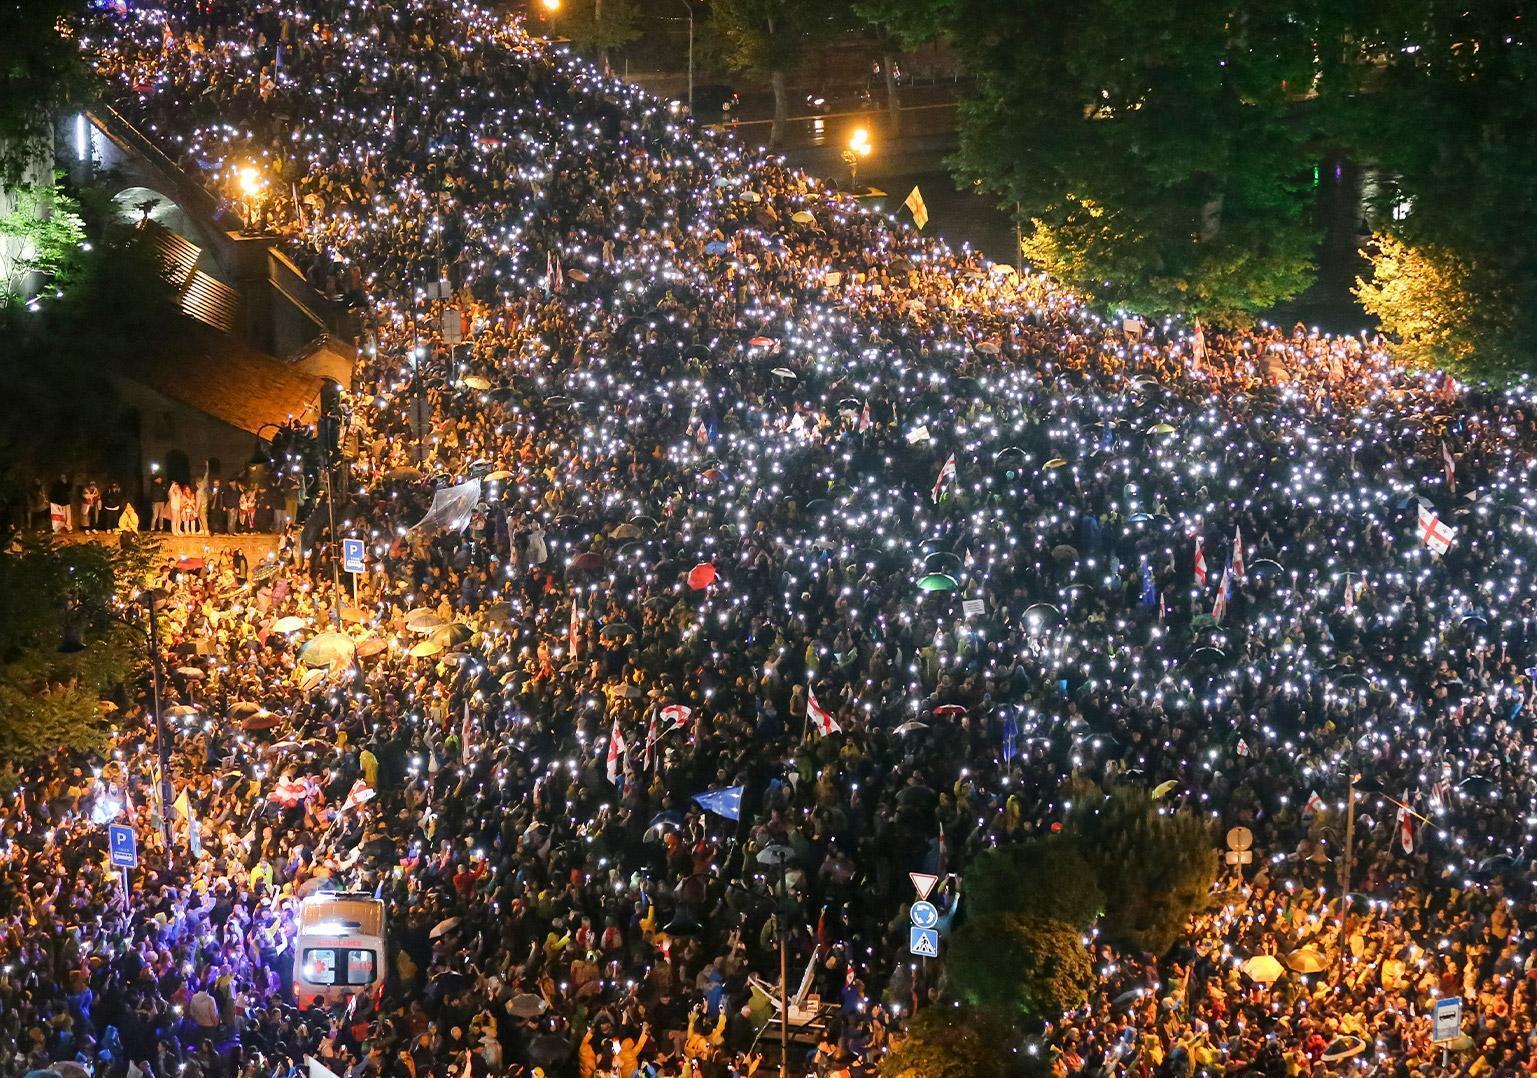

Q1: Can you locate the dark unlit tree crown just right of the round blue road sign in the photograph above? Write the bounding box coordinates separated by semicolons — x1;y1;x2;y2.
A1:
965;835;1105;930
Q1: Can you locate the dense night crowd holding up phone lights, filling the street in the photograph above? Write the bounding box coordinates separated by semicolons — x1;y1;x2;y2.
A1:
9;0;1537;1078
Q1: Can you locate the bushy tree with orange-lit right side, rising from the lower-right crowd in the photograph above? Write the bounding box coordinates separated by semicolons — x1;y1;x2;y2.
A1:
1064;781;1217;955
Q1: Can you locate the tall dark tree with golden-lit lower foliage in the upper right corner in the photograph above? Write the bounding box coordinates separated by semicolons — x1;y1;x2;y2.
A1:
1334;0;1537;377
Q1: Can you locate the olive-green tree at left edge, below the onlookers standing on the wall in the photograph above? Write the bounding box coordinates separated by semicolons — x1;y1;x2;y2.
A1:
0;538;149;761
